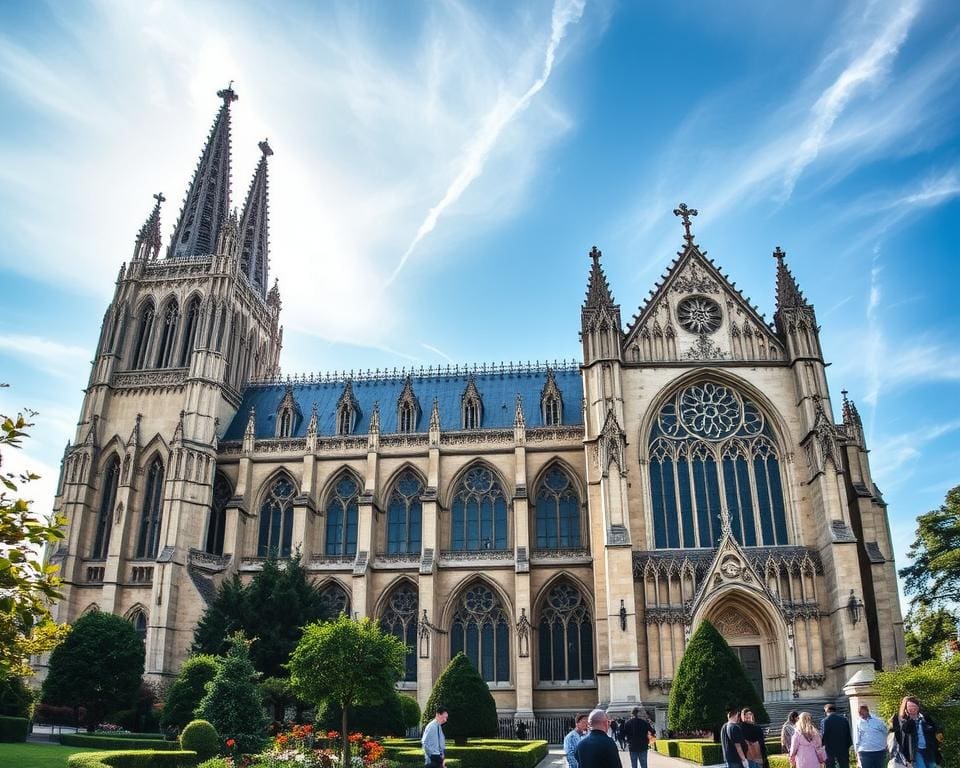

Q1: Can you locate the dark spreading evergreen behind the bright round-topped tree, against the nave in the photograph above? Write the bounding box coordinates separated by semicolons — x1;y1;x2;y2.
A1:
193;555;330;677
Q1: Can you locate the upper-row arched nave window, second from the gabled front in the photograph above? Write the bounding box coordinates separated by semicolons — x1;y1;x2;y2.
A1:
450;467;507;552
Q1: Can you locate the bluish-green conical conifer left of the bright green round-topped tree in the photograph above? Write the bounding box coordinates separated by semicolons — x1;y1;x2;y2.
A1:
197;635;267;753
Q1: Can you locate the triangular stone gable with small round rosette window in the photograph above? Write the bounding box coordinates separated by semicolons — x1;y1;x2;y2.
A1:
623;248;784;363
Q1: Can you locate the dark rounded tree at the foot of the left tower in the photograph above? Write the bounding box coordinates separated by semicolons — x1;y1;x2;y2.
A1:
42;611;144;730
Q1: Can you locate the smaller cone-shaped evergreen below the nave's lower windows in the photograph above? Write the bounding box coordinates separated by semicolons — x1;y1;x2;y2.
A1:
421;652;497;744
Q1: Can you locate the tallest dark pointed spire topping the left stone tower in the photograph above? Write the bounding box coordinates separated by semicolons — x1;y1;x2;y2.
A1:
168;81;237;258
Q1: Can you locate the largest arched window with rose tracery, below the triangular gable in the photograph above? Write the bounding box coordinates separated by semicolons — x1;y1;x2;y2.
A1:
648;381;788;548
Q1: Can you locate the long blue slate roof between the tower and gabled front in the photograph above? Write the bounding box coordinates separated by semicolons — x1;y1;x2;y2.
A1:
223;365;583;440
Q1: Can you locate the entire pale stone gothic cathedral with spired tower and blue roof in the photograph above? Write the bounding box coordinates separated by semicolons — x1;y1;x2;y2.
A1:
51;88;906;727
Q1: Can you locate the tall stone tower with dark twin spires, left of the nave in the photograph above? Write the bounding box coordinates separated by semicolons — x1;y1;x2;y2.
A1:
52;87;282;675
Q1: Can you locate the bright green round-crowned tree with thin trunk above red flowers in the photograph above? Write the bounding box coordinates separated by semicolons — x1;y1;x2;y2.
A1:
289;616;407;765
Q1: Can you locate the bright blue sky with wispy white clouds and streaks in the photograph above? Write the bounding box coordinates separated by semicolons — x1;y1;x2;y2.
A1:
0;0;960;612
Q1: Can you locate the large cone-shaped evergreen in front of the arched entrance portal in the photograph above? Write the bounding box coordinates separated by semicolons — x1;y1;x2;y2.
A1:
667;621;769;735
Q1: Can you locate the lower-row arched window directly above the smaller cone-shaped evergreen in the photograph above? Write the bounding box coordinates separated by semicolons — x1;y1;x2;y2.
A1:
450;584;510;683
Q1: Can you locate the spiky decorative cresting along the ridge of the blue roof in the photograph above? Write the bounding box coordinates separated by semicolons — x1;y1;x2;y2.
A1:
248;360;581;387
